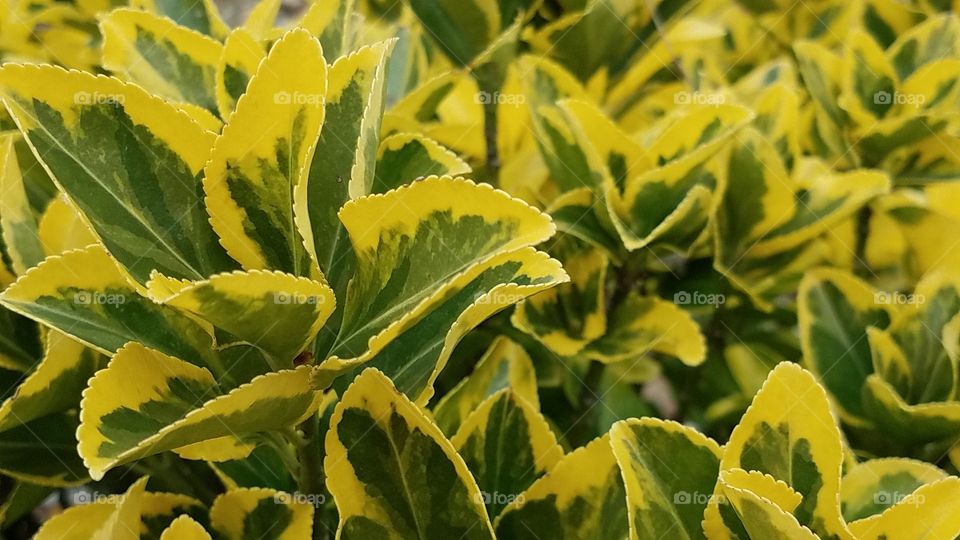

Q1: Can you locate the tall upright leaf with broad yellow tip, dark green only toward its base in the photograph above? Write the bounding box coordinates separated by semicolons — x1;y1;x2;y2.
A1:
203;30;326;276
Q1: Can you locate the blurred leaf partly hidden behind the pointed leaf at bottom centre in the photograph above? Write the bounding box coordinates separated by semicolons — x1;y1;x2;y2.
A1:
433;337;540;437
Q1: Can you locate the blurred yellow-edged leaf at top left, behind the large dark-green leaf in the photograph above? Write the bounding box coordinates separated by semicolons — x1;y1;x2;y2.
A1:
101;9;223;113
